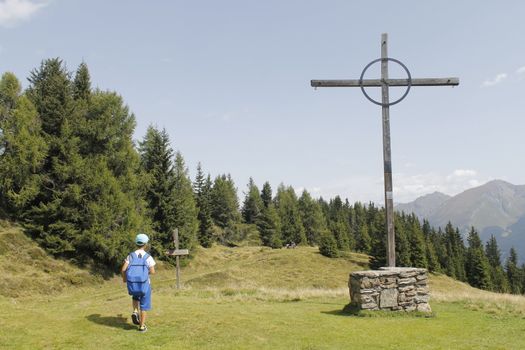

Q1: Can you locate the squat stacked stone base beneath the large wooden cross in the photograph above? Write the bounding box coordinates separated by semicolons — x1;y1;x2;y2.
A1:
348;267;432;313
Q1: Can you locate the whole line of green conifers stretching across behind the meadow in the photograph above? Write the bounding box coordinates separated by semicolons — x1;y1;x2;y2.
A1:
0;58;525;293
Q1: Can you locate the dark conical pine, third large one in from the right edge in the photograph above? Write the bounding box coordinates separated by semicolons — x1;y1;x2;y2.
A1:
466;227;493;290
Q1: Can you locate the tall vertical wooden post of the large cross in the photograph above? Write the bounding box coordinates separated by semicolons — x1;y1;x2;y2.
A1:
381;33;396;267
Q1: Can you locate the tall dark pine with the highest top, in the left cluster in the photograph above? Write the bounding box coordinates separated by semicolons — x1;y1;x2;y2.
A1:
26;59;85;256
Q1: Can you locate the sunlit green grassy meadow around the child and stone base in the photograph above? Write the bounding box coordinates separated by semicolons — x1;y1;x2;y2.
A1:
0;223;525;349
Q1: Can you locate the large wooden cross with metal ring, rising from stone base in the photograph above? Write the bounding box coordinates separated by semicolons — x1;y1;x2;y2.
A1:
310;33;459;267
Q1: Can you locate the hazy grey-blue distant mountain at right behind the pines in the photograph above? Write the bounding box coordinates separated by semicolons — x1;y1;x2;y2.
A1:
396;180;525;261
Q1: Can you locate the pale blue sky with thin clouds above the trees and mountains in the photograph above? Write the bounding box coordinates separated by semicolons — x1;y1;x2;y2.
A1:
0;0;525;203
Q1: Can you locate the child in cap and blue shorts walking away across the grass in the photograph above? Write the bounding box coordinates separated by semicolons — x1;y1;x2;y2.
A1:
121;233;156;332
